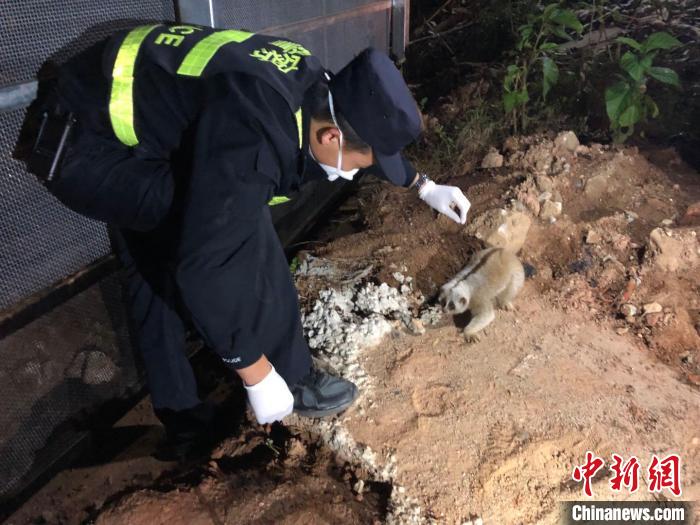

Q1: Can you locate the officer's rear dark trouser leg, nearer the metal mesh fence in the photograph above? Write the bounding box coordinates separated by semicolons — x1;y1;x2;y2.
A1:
113;230;200;413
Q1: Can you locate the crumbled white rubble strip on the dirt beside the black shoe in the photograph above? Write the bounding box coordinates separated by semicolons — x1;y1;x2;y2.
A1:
298;272;432;525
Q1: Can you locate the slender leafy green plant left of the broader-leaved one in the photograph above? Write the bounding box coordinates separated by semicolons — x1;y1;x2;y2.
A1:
503;3;583;133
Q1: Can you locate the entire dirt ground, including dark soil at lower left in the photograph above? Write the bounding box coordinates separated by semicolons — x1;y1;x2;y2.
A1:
9;129;700;525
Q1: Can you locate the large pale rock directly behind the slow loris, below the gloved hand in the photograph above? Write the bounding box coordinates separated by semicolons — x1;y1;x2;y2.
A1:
465;209;532;252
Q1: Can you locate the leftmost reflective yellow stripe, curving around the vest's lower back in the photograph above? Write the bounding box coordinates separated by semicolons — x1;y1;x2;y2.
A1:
109;25;158;146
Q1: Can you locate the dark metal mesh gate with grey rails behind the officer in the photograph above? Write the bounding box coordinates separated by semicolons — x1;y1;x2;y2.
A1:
0;0;408;517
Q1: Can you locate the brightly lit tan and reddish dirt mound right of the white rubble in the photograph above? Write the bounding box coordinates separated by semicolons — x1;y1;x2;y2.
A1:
302;137;700;525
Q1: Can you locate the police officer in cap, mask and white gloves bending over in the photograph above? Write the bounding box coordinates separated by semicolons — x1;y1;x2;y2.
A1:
41;25;469;456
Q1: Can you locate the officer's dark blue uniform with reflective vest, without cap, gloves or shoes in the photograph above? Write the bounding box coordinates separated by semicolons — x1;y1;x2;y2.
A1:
52;26;412;410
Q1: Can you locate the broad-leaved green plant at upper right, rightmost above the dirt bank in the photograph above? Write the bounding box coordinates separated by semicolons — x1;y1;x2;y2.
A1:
605;32;681;142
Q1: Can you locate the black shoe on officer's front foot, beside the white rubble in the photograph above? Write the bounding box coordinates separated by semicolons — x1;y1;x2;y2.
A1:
292;369;359;417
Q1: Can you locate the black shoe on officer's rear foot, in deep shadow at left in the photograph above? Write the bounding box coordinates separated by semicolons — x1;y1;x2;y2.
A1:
154;402;222;462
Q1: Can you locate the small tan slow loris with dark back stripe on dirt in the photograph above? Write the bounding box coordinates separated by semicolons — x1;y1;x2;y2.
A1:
439;248;525;342
